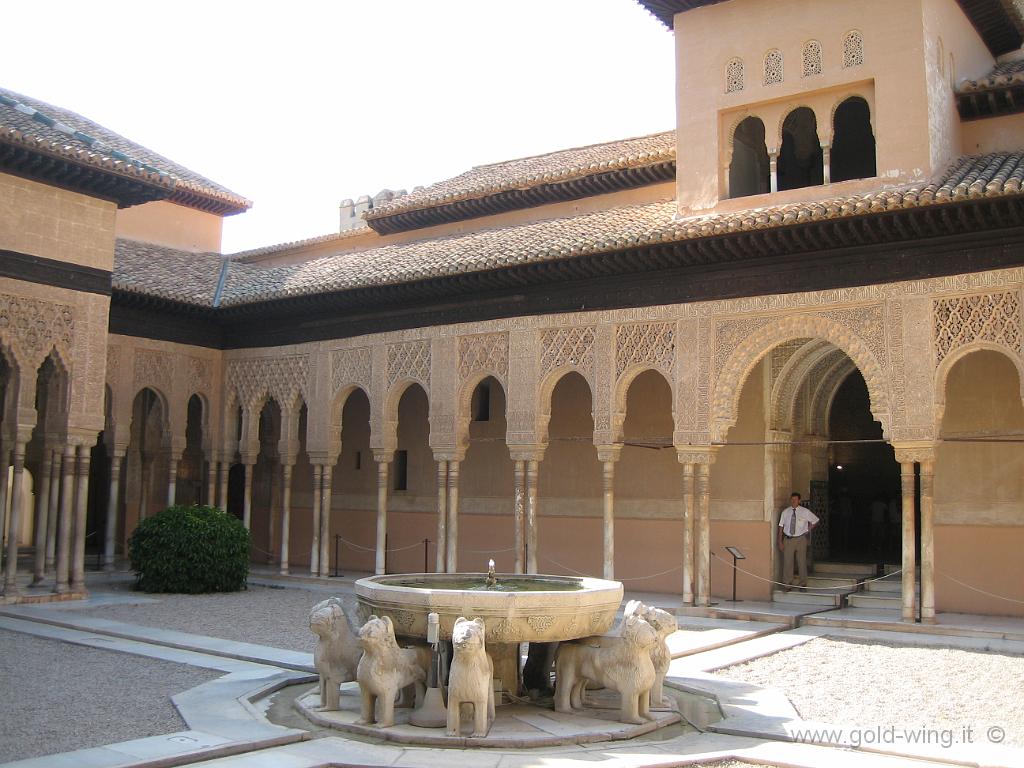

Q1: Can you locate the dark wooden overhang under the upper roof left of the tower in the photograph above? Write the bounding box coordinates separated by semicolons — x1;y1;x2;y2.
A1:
366;160;676;234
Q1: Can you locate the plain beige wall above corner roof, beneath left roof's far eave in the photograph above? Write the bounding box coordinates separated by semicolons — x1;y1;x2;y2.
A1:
116;201;223;253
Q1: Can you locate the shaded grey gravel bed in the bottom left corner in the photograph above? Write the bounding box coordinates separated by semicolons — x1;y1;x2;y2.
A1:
0;630;219;763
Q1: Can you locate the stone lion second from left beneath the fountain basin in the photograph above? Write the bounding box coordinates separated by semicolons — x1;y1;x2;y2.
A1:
355;615;430;728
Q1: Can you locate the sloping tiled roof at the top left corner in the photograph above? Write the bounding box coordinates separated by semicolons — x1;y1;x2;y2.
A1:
0;88;252;213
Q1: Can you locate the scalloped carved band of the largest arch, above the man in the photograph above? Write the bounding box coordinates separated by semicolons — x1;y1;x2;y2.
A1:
710;314;892;440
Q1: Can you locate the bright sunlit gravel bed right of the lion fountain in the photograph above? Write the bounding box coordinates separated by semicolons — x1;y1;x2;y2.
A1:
715;638;1024;746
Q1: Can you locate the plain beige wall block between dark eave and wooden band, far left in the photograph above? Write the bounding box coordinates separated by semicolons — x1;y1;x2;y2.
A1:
0;173;117;271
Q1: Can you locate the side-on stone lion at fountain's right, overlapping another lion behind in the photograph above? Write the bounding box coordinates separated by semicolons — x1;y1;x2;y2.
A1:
555;613;657;725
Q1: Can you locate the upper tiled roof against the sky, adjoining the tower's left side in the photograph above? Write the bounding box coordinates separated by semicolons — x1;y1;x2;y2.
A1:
366;131;676;221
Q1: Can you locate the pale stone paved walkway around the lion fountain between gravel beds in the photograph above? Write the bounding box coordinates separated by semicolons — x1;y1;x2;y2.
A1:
0;572;1024;768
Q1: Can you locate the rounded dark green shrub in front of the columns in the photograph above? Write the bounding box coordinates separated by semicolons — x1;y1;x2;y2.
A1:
128;506;249;594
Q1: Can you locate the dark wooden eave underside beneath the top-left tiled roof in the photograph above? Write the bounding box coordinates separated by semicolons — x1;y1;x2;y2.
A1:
0;135;172;208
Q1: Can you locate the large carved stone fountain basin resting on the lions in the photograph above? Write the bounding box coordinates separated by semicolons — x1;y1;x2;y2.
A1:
355;573;623;644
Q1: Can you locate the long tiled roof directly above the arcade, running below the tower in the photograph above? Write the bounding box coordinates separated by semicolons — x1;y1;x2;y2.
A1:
114;151;1024;307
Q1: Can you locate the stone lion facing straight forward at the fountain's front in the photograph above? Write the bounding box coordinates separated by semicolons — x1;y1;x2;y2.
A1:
447;616;495;738
